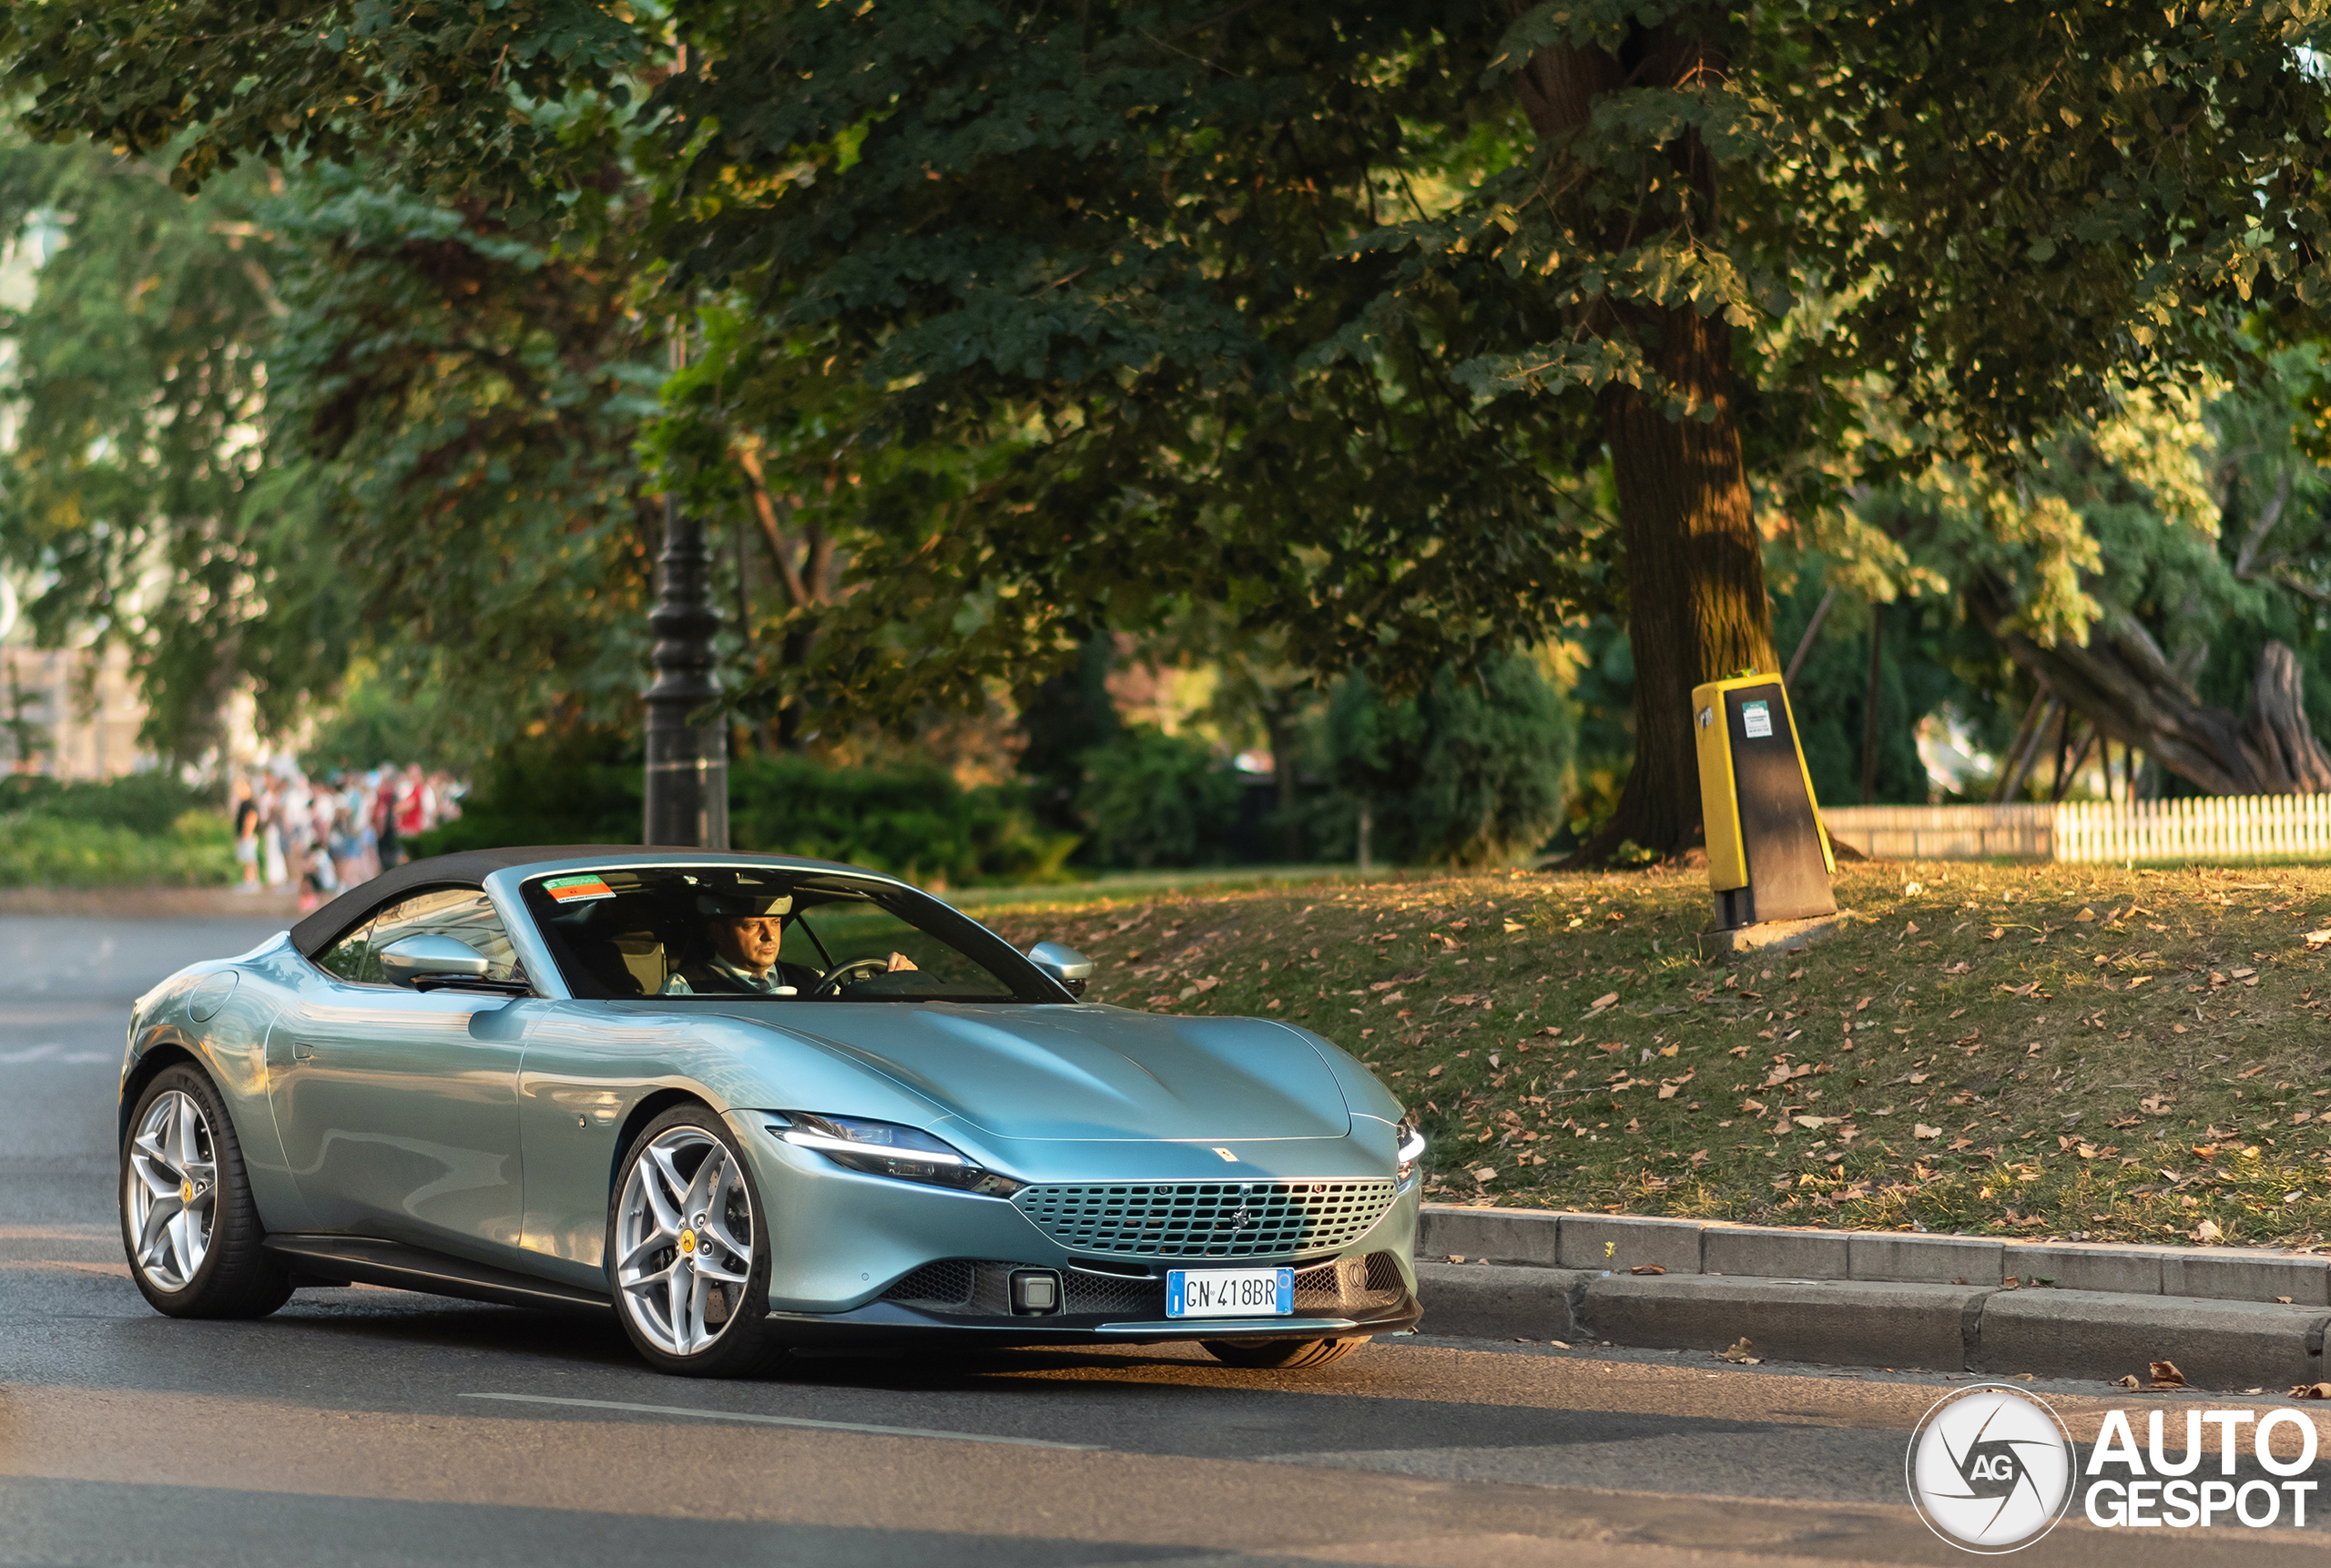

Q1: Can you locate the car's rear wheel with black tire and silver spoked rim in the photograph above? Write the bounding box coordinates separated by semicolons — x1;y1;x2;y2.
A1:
119;1063;291;1319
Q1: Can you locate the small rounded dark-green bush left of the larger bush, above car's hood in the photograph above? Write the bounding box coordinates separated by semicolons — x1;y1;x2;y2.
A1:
1077;725;1240;871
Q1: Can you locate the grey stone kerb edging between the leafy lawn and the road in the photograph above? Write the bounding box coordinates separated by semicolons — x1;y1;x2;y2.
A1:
1417;1205;2331;1393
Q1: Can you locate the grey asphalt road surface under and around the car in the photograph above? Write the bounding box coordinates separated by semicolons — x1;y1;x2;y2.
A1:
0;918;2331;1568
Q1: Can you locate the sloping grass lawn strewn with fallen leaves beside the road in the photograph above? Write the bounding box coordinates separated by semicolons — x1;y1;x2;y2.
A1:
969;862;2331;1247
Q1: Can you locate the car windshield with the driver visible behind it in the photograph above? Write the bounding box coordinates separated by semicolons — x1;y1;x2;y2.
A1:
524;867;1061;1002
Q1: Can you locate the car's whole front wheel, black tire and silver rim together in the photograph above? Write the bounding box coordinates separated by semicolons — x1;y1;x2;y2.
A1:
606;1105;781;1377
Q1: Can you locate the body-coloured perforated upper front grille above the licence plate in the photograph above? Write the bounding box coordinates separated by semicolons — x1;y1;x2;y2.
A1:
1012;1179;1394;1258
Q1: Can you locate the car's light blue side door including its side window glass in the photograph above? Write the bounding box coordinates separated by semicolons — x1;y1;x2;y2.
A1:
268;888;536;1260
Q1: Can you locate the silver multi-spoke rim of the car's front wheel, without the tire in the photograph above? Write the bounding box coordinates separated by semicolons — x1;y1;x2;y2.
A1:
616;1127;753;1356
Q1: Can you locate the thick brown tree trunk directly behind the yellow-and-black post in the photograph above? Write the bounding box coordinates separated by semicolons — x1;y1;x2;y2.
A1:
1515;18;1781;864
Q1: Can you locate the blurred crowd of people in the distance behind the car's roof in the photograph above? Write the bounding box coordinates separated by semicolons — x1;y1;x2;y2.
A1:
233;759;462;913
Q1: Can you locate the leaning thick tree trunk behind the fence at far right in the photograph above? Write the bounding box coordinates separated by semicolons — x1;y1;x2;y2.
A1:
1968;578;2331;795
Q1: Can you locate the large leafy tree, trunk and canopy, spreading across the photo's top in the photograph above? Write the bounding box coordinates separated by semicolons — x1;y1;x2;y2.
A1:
0;0;2331;850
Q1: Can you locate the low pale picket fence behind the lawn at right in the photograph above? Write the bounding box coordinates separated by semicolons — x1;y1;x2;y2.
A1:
1820;795;2331;862
